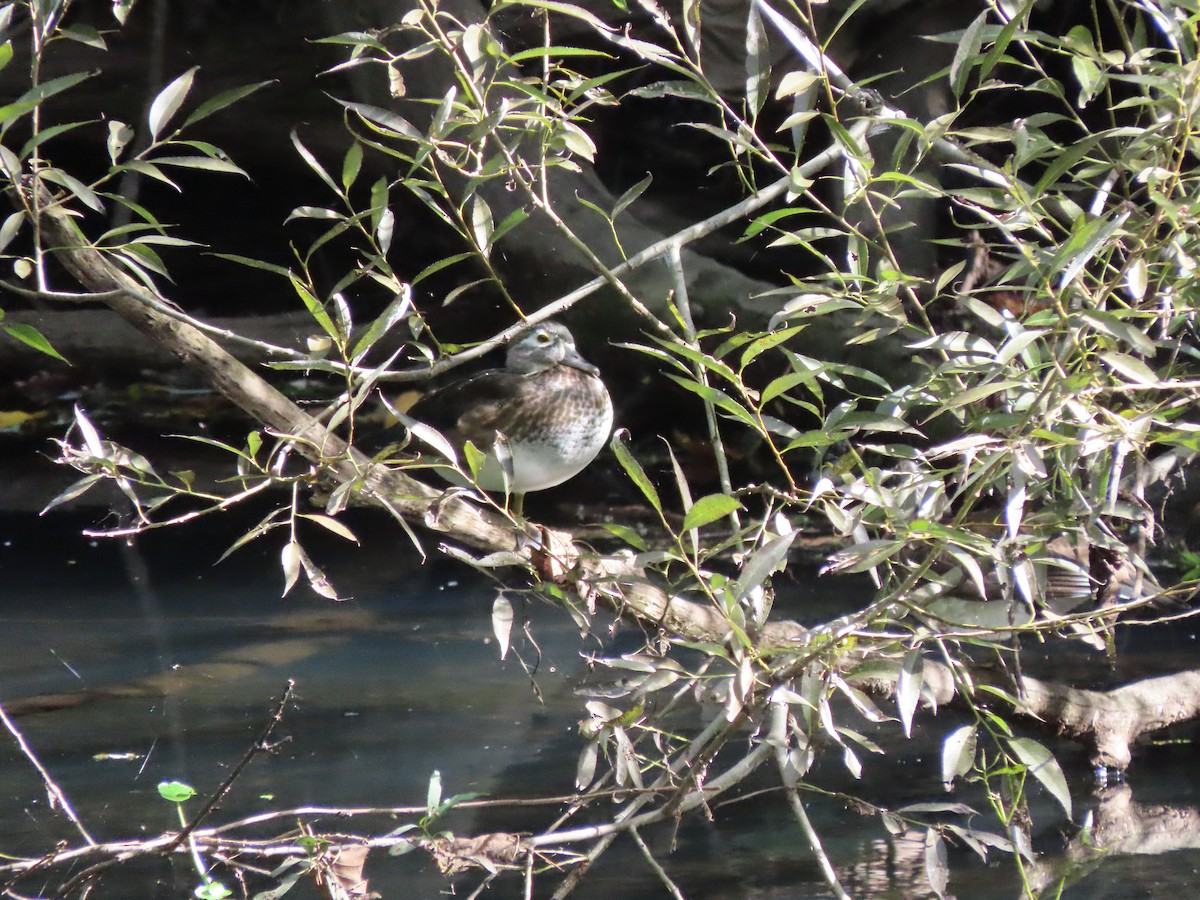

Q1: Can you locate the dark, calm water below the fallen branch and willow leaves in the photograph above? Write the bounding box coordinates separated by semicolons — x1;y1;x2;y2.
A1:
0;515;1200;899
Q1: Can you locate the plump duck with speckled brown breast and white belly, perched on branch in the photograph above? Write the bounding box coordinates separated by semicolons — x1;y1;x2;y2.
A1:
384;322;612;514
